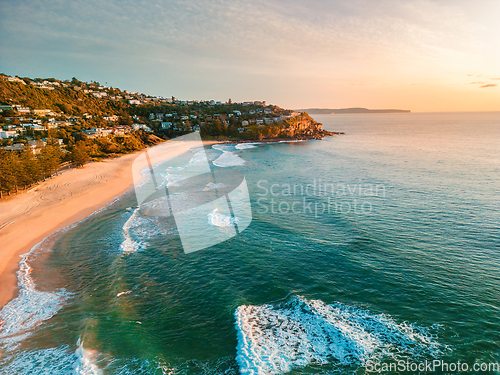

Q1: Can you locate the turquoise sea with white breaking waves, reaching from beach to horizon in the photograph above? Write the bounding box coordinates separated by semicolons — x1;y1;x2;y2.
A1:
0;113;500;374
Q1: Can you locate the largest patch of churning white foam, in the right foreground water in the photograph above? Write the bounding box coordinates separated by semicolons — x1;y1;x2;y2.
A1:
235;297;444;375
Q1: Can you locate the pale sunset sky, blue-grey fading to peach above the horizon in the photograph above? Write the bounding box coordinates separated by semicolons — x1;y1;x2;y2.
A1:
0;0;500;112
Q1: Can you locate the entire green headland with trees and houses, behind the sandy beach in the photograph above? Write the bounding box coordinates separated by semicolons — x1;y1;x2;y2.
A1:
0;74;333;196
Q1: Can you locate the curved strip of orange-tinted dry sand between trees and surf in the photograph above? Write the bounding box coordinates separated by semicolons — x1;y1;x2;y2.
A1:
0;141;200;308
